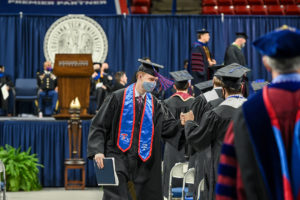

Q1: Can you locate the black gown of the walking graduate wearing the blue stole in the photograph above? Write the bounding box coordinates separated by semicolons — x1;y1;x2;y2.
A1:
87;89;184;200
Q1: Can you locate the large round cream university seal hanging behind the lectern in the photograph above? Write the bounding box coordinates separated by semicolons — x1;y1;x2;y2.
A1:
44;15;108;63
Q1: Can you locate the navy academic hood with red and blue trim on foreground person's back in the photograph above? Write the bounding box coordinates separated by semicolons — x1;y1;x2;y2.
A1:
243;81;300;200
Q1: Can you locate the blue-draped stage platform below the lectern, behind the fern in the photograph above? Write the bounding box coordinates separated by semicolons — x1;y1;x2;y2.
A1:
0;115;97;187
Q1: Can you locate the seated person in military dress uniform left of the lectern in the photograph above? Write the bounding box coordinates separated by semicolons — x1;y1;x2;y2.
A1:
37;61;58;117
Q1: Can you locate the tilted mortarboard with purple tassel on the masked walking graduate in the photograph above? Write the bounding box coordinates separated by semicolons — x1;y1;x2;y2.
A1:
138;59;173;90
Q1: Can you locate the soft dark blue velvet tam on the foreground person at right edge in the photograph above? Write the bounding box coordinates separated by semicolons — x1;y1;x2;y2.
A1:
253;25;300;58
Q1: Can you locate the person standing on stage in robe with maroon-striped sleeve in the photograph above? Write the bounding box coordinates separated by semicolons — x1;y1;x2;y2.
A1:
190;29;216;95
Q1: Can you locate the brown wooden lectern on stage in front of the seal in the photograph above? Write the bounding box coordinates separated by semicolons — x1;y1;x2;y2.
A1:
53;54;94;119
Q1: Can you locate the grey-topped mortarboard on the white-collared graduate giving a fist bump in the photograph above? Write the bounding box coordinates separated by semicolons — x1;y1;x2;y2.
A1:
215;63;251;89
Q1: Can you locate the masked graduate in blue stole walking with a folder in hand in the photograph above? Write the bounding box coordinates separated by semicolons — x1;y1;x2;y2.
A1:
87;59;184;200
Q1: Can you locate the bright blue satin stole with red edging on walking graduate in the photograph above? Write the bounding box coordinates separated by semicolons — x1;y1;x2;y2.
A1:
117;84;154;162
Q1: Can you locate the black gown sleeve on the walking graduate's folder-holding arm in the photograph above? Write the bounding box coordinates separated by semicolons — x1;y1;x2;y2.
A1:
87;94;118;159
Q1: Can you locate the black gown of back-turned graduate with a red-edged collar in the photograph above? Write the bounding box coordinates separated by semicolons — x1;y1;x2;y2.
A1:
163;95;194;197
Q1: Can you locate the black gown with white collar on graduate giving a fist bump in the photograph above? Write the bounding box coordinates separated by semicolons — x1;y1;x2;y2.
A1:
185;98;245;199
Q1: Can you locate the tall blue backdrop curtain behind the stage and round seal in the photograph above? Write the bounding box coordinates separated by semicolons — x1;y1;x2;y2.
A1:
0;14;300;84
